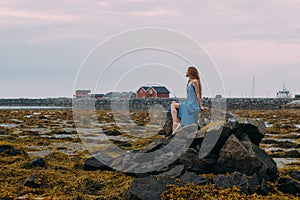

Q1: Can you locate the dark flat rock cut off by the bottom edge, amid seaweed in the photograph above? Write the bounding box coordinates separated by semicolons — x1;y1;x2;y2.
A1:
125;176;175;200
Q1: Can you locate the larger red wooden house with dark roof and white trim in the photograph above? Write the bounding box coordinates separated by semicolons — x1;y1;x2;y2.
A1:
136;86;170;99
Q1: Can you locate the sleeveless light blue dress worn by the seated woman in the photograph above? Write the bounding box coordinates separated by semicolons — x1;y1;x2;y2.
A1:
178;83;201;126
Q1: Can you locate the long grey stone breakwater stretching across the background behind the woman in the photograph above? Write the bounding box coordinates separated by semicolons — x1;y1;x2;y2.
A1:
0;98;295;110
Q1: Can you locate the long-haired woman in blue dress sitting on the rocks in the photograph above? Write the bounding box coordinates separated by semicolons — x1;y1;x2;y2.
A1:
171;67;208;134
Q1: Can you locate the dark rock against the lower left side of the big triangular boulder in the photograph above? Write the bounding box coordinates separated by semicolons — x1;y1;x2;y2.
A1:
179;148;212;174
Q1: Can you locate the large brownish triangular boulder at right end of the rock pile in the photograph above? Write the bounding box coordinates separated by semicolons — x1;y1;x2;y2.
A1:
213;135;278;181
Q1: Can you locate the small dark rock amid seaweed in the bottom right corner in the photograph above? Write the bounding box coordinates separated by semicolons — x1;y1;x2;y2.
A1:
278;177;300;195
